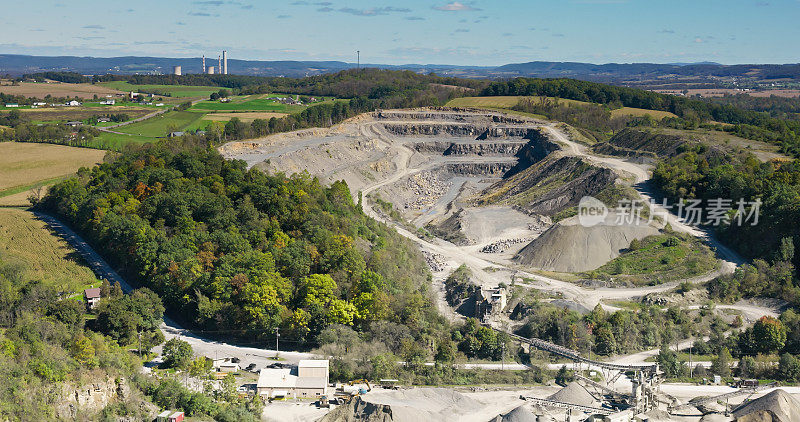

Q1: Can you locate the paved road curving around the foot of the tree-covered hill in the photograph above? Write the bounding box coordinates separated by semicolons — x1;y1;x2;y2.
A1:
34;212;315;369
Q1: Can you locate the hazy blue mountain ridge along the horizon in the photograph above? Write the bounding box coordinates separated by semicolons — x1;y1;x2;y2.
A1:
0;54;800;83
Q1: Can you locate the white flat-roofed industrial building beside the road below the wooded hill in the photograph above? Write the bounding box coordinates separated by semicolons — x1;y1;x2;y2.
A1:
256;360;330;398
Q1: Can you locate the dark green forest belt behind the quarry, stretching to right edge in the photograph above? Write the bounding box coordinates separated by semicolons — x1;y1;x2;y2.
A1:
481;78;800;156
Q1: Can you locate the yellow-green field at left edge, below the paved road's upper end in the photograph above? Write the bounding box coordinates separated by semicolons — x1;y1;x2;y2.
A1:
0;208;98;291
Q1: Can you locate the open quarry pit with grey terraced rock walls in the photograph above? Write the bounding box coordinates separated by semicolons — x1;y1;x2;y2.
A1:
220;109;664;271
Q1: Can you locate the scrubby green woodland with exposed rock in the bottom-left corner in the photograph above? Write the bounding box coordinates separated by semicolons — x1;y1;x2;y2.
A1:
0;251;260;422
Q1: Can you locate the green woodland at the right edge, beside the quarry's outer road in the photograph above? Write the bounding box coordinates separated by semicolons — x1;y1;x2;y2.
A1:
653;146;800;305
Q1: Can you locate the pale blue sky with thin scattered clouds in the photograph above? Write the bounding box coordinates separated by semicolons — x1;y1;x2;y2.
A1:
0;0;800;65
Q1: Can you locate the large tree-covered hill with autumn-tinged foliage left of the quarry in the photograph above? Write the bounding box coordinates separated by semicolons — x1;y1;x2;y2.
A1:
39;140;440;343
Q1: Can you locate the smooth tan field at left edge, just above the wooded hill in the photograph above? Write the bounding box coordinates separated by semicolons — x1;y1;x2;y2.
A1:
0;142;106;197
